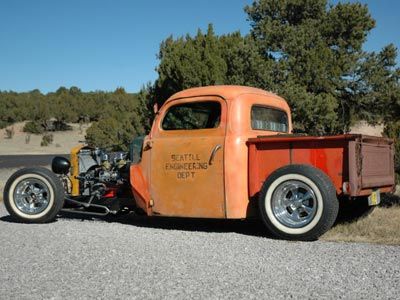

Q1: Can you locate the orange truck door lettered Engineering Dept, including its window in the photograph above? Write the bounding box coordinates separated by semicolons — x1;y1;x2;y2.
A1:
150;97;226;218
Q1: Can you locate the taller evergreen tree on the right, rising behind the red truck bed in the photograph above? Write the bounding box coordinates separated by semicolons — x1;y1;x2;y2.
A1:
245;0;399;134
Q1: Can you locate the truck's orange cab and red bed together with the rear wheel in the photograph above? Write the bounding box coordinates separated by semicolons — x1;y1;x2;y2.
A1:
130;86;394;239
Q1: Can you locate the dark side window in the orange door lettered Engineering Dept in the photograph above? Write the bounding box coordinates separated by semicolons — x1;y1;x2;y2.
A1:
162;101;221;130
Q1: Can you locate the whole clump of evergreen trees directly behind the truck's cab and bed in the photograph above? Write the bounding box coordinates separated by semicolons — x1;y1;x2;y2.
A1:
142;0;399;135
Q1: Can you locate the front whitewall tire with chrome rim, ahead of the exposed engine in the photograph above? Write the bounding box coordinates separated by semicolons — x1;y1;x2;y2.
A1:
3;168;64;223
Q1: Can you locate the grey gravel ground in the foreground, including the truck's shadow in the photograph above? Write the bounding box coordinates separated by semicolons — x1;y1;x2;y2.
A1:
0;203;400;299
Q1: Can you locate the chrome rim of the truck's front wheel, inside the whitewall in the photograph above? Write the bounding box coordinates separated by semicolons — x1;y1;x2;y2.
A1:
13;178;50;215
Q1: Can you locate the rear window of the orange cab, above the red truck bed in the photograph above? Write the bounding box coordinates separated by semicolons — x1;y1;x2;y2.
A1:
251;105;288;132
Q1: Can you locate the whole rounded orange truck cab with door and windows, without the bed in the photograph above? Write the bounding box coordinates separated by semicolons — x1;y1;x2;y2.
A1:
130;86;292;219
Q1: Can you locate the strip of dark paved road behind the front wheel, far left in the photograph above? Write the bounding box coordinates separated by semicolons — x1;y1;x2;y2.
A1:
0;154;69;169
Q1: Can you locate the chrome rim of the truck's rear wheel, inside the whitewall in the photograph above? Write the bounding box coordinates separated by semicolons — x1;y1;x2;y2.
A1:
271;180;317;228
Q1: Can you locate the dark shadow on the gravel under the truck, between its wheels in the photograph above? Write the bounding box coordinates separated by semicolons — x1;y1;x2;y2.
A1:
59;212;273;238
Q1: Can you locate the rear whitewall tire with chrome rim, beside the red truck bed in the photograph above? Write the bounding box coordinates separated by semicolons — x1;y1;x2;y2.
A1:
259;165;339;241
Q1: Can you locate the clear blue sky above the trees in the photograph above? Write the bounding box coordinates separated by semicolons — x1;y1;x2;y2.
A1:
0;0;400;93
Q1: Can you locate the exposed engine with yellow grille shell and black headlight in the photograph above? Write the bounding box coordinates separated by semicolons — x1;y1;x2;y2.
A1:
51;137;143;216
